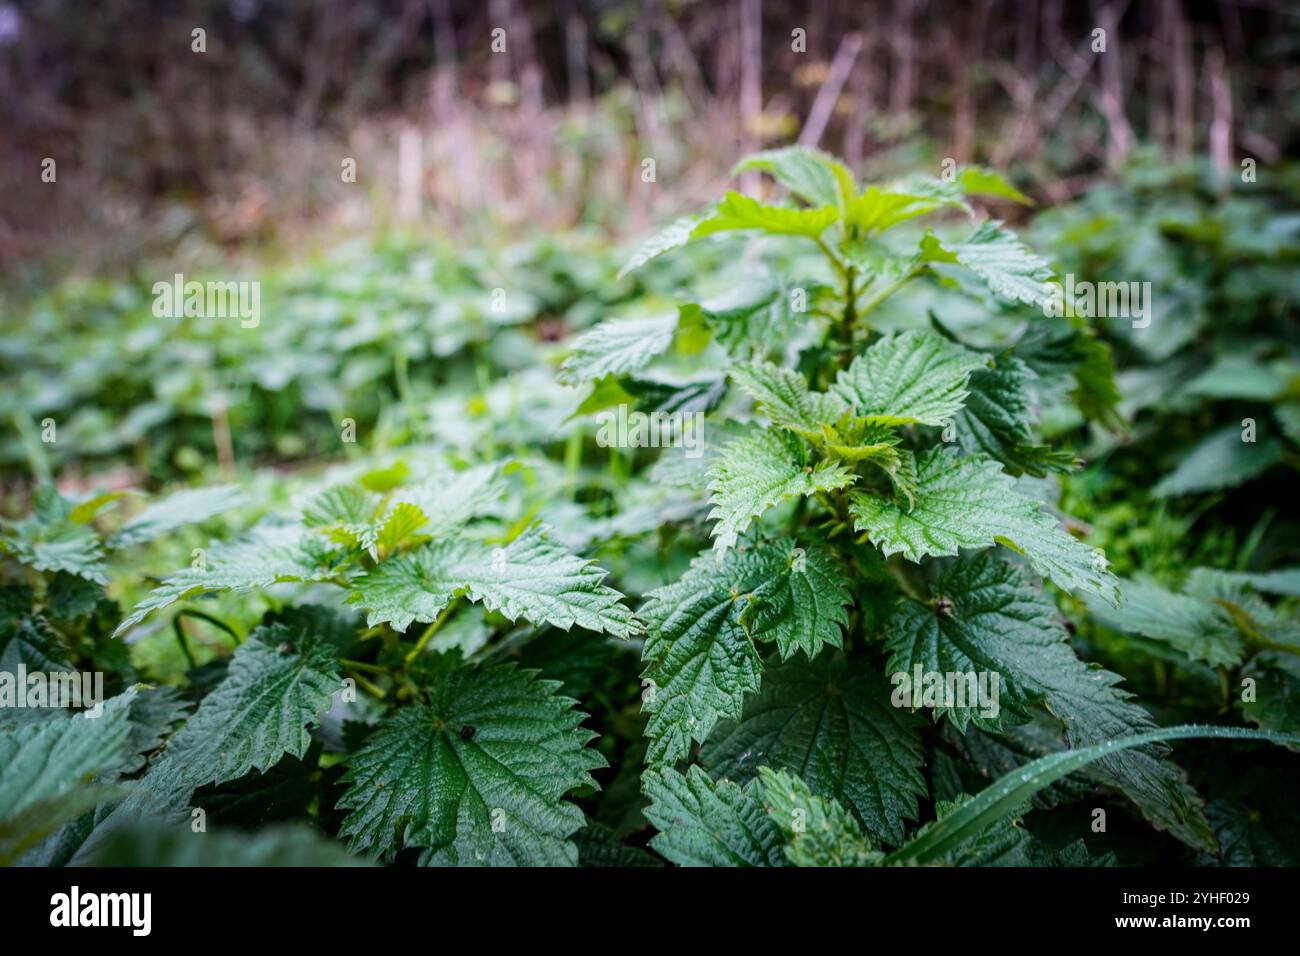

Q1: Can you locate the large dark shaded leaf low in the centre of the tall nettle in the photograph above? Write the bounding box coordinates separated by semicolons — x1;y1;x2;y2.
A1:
702;654;926;843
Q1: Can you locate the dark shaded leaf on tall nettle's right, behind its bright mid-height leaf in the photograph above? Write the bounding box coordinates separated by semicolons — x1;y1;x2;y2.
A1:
953;355;1078;477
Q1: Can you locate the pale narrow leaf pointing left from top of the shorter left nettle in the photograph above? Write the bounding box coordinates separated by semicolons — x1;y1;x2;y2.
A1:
113;524;343;637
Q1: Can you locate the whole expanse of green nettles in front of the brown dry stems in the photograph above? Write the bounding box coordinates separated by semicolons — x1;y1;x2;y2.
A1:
0;150;1300;865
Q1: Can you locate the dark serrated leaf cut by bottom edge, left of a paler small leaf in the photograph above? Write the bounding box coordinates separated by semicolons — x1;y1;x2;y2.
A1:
642;766;785;866
